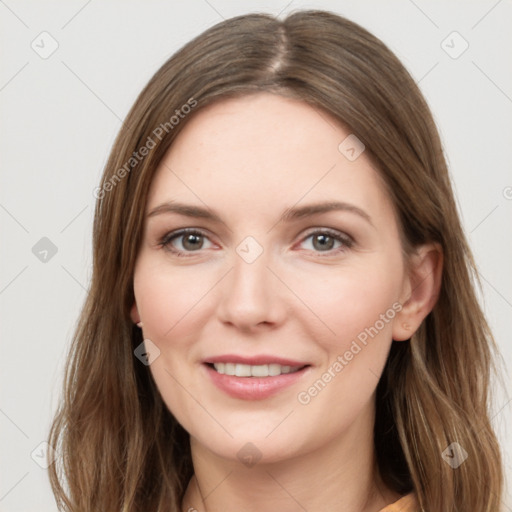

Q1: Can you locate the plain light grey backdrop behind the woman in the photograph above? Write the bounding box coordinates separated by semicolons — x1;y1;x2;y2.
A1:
0;0;512;512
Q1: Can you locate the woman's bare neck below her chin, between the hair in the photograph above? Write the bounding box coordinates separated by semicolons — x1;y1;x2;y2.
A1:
182;402;399;512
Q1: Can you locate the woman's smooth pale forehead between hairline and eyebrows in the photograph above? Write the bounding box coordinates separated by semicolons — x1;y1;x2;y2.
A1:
148;93;392;224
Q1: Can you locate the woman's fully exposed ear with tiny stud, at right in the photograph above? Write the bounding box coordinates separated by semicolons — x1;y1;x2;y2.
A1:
393;244;443;341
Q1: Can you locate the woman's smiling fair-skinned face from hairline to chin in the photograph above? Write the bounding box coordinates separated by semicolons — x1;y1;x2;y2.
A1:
132;93;410;463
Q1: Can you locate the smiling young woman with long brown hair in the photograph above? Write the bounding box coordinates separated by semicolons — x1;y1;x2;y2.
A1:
49;11;502;512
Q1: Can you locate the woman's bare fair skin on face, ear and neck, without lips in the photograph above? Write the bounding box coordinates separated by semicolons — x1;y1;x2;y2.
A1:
131;93;441;512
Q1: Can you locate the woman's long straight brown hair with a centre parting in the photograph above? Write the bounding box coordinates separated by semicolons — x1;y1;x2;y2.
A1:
49;11;502;512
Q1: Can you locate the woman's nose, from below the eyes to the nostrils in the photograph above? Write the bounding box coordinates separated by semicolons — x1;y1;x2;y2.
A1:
218;247;286;332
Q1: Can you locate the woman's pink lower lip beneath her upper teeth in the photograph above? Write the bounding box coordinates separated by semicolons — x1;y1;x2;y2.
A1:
204;365;309;400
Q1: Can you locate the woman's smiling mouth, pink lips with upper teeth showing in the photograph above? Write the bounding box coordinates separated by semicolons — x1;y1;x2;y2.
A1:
204;355;310;400
